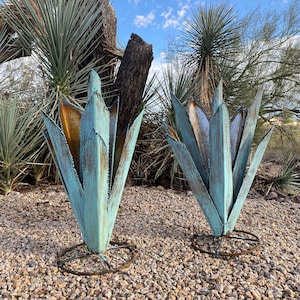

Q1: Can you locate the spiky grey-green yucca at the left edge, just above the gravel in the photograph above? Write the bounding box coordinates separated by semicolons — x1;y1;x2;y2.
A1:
0;97;43;195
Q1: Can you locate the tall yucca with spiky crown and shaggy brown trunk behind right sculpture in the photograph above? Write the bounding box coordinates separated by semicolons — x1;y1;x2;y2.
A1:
182;4;240;113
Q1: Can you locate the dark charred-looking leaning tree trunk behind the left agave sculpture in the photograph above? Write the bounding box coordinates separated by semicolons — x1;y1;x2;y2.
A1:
115;33;153;136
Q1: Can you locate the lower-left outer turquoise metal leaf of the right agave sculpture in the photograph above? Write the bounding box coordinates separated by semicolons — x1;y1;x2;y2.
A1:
167;129;223;236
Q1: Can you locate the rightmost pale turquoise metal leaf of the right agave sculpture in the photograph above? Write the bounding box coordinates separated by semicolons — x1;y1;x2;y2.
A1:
228;128;273;231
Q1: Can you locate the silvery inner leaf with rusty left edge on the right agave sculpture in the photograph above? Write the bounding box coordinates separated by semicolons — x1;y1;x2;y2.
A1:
188;99;209;170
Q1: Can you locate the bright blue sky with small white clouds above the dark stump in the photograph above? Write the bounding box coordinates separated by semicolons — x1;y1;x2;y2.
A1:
111;0;291;60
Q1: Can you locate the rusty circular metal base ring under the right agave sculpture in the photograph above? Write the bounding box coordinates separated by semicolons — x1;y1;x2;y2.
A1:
191;230;260;257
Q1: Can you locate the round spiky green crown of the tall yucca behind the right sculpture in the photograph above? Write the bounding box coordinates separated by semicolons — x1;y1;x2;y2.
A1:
182;4;240;71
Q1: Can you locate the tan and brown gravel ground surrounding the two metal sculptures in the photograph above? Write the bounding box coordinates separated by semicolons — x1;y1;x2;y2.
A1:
0;186;300;299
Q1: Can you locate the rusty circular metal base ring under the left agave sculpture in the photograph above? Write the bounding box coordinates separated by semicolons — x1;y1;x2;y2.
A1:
57;242;137;276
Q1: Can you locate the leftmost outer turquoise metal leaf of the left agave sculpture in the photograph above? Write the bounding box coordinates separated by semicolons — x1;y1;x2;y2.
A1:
43;114;85;235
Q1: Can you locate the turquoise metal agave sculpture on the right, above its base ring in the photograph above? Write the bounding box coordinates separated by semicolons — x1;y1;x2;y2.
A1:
164;81;272;236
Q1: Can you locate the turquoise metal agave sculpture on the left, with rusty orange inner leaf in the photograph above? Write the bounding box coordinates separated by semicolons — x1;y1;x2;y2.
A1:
44;71;143;253
